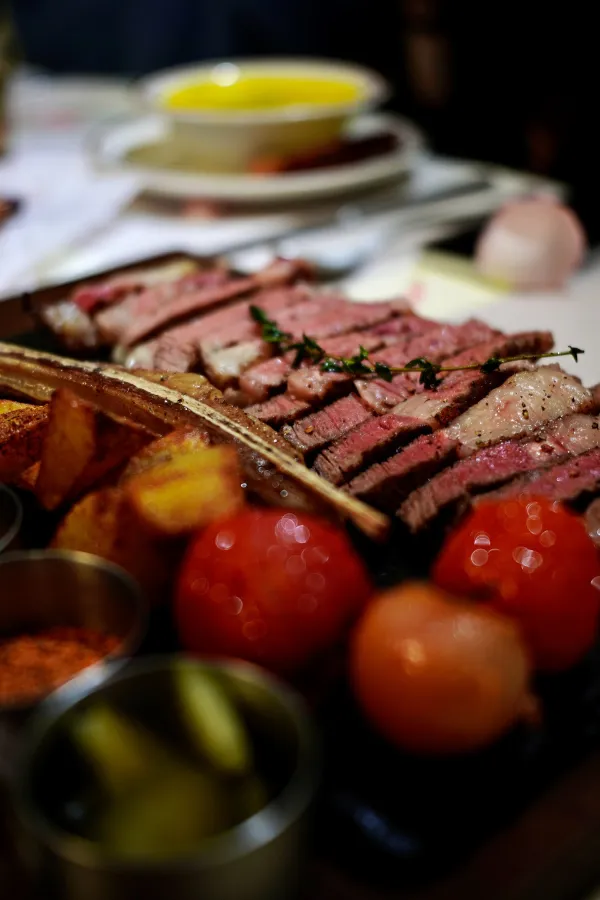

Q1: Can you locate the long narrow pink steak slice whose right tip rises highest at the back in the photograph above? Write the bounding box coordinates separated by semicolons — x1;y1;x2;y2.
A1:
97;260;306;347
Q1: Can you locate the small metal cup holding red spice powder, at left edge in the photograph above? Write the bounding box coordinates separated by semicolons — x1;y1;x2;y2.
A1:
0;550;147;714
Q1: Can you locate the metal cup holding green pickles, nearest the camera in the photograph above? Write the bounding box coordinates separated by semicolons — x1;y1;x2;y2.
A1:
16;657;317;900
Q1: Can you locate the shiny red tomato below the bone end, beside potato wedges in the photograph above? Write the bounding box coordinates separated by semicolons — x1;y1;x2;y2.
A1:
176;509;371;673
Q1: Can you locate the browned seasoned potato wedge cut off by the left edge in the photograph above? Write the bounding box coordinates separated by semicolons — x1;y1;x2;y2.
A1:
0;400;48;482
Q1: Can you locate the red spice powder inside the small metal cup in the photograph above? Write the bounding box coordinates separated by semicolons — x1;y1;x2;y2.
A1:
0;627;121;704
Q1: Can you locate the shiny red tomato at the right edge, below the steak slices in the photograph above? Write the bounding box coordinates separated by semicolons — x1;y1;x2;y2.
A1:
433;497;600;670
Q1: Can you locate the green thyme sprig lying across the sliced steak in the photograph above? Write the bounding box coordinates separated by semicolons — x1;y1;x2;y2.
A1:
250;306;585;389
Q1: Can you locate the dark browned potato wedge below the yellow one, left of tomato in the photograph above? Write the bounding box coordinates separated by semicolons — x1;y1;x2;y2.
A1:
51;487;176;603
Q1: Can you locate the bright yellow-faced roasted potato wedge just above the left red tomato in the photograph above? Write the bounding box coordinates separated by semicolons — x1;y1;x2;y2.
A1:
124;446;244;536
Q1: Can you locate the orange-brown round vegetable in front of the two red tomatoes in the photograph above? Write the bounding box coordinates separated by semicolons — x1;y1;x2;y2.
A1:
351;582;532;754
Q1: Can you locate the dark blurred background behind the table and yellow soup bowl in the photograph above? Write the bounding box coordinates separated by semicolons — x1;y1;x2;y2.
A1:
13;0;600;241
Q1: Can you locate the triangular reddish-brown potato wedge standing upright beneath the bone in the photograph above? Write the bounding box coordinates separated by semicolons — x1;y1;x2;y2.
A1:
35;388;152;510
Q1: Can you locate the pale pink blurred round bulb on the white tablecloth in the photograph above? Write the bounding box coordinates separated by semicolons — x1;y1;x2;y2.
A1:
475;197;587;291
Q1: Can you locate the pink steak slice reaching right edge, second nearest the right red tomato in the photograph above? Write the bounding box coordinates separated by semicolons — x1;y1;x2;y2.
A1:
397;415;600;532
